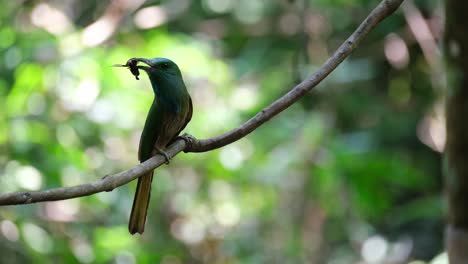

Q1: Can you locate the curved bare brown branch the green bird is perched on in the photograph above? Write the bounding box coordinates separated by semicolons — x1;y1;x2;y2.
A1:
0;0;403;205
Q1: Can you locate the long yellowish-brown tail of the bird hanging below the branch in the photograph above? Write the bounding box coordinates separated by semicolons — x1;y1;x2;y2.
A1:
128;171;153;235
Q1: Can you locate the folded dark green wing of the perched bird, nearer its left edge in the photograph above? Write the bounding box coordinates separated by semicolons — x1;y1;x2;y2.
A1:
138;100;164;162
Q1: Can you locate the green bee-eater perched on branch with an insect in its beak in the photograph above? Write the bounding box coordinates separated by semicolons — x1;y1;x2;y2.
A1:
114;58;193;235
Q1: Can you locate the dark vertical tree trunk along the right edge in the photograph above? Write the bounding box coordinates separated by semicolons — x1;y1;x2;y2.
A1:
444;0;468;264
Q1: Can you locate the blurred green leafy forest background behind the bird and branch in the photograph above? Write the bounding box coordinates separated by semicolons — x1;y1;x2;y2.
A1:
0;0;445;264
